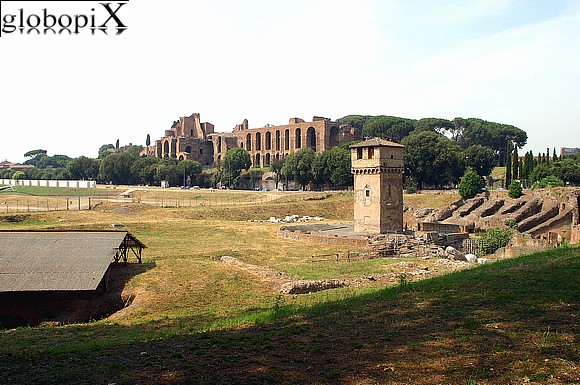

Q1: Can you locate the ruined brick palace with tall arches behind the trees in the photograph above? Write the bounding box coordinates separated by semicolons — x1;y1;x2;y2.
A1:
141;113;361;167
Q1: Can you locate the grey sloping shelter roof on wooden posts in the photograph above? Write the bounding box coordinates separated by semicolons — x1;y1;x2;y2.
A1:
0;231;146;293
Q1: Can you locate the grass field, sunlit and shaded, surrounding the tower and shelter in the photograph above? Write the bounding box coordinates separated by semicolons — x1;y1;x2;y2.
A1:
0;191;580;384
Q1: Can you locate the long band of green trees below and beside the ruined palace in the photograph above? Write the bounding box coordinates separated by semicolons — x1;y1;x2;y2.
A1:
0;115;580;191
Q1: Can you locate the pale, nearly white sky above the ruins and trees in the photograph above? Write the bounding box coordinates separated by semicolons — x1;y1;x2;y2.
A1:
0;0;580;162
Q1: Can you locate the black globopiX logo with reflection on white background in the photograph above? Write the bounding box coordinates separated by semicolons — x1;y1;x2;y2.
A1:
0;0;129;37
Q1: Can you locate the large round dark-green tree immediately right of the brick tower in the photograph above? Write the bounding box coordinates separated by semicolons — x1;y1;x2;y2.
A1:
403;131;465;190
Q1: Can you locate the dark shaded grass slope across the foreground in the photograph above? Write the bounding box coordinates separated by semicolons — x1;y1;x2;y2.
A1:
0;249;580;384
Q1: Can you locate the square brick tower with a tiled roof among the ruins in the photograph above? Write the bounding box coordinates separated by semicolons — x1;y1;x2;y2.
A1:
350;138;404;234
